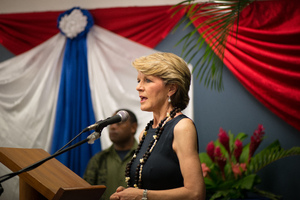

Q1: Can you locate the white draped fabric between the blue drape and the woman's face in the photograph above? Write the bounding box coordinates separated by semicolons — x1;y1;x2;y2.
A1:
87;26;156;149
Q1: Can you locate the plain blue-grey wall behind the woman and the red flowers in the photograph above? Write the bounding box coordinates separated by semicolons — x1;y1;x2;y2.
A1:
0;21;300;199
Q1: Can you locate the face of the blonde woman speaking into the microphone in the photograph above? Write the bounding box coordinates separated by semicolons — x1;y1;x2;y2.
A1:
136;72;169;112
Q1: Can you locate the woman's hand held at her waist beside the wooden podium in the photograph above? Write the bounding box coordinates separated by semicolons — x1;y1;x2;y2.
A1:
110;186;143;200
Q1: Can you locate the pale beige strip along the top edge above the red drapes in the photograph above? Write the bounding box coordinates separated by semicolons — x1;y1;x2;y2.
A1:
0;0;209;14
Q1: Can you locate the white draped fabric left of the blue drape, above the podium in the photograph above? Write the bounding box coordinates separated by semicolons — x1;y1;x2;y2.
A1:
0;34;65;149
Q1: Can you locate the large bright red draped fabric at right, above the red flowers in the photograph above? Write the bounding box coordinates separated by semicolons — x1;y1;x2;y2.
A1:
190;0;300;130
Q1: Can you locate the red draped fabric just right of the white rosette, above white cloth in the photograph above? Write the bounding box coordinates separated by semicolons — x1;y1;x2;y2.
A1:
90;6;185;48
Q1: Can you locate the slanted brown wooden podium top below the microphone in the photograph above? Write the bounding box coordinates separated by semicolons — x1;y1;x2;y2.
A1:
0;147;105;199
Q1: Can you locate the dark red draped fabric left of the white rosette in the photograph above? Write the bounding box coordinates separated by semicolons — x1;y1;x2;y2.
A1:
0;12;60;55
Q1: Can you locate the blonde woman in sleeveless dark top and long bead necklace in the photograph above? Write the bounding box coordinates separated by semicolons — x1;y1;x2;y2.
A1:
110;53;205;200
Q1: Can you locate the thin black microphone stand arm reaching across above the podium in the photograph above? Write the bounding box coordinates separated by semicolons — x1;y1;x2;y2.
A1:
0;127;102;183
